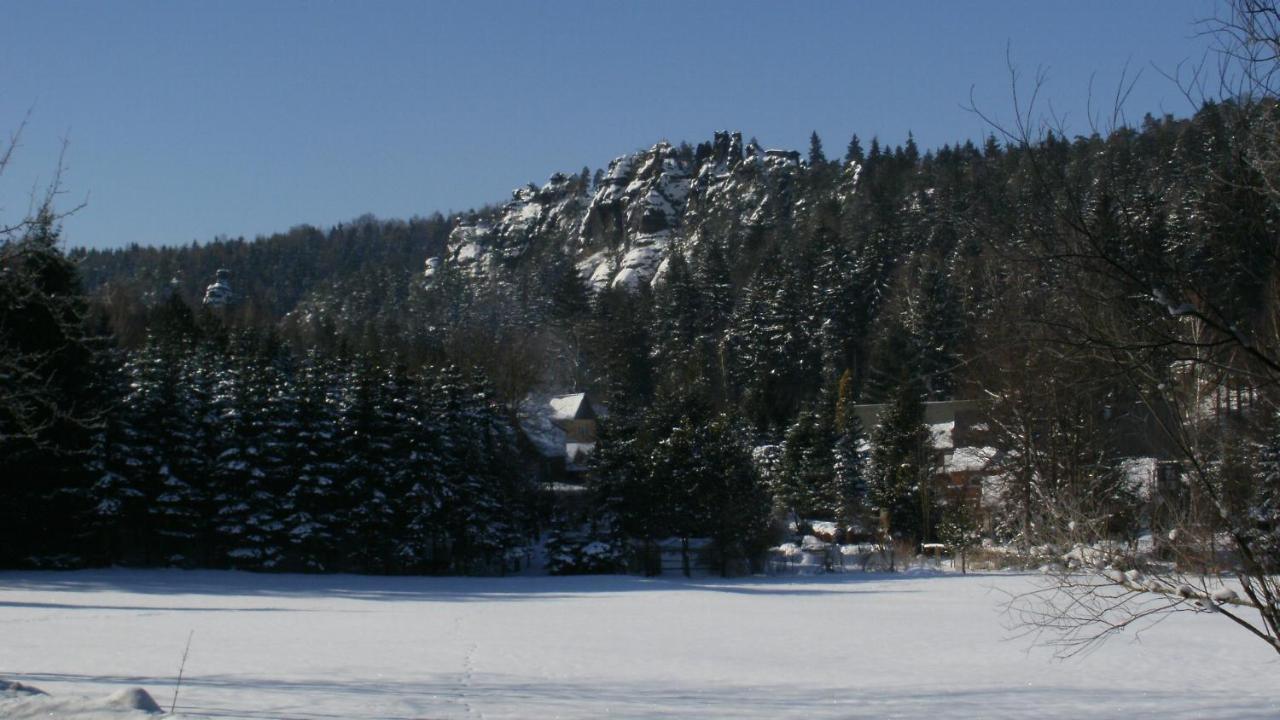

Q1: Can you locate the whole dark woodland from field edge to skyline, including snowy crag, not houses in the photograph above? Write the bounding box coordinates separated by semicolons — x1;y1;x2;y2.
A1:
15;100;1280;577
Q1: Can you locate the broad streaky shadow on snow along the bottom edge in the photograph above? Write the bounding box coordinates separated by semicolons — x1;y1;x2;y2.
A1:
5;673;1276;720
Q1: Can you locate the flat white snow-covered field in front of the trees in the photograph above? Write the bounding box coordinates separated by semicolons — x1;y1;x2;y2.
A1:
0;570;1280;719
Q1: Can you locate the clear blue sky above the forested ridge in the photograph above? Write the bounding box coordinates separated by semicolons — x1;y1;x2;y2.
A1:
0;0;1216;246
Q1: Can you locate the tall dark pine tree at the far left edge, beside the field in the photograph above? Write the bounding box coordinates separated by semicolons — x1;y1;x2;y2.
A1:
0;206;105;566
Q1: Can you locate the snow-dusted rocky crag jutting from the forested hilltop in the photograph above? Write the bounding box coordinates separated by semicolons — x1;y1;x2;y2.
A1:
424;132;803;291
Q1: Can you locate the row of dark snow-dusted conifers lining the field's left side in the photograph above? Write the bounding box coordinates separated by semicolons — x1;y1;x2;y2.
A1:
0;230;532;573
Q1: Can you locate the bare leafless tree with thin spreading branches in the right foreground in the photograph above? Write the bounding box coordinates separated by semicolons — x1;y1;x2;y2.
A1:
967;0;1280;655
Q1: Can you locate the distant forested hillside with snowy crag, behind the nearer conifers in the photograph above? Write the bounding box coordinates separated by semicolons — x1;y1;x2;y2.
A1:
78;105;1270;432
